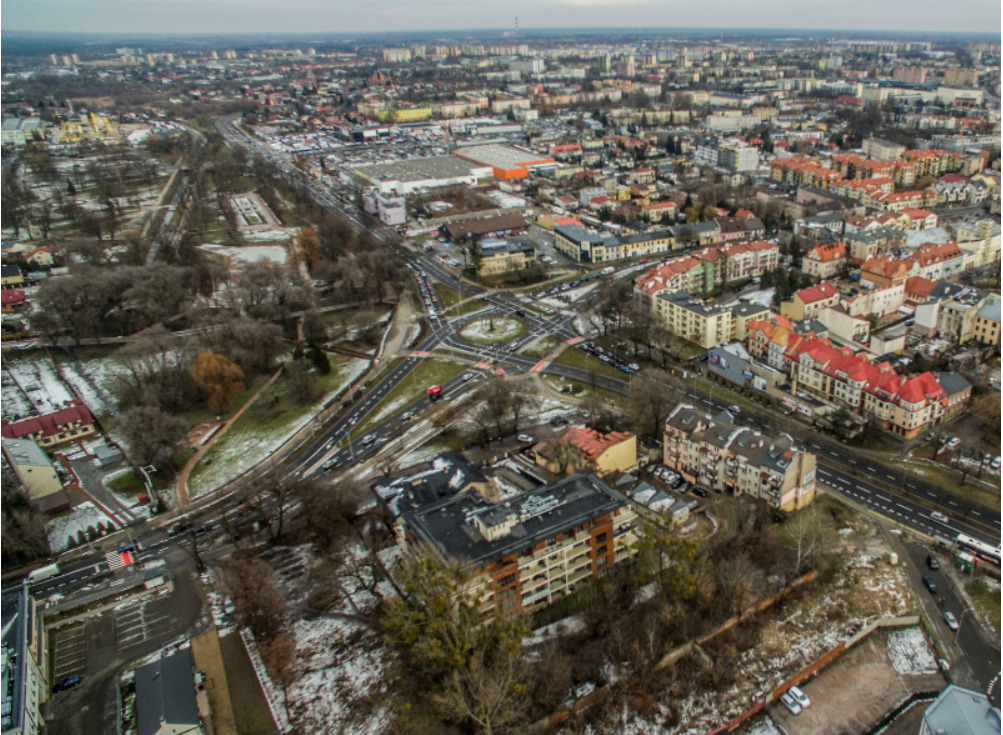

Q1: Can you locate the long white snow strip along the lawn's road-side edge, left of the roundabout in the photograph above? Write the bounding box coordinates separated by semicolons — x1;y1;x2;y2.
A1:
189;359;369;497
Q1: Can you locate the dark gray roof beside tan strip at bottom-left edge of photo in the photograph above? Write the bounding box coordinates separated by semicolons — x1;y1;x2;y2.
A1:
135;649;201;735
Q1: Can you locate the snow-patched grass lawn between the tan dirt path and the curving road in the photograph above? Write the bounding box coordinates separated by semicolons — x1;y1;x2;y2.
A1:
189;354;368;497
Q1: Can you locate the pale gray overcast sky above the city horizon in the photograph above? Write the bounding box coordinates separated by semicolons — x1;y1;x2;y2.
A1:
0;0;1001;35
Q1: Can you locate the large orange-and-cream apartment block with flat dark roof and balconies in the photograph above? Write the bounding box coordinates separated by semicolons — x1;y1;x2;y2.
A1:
398;472;637;616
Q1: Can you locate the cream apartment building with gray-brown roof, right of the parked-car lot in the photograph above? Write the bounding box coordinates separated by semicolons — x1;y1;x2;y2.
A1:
662;403;816;511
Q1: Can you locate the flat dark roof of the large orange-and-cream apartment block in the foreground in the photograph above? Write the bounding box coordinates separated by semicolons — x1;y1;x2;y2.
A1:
403;472;628;565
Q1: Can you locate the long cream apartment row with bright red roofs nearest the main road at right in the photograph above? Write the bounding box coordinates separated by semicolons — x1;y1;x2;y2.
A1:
784;335;947;439
